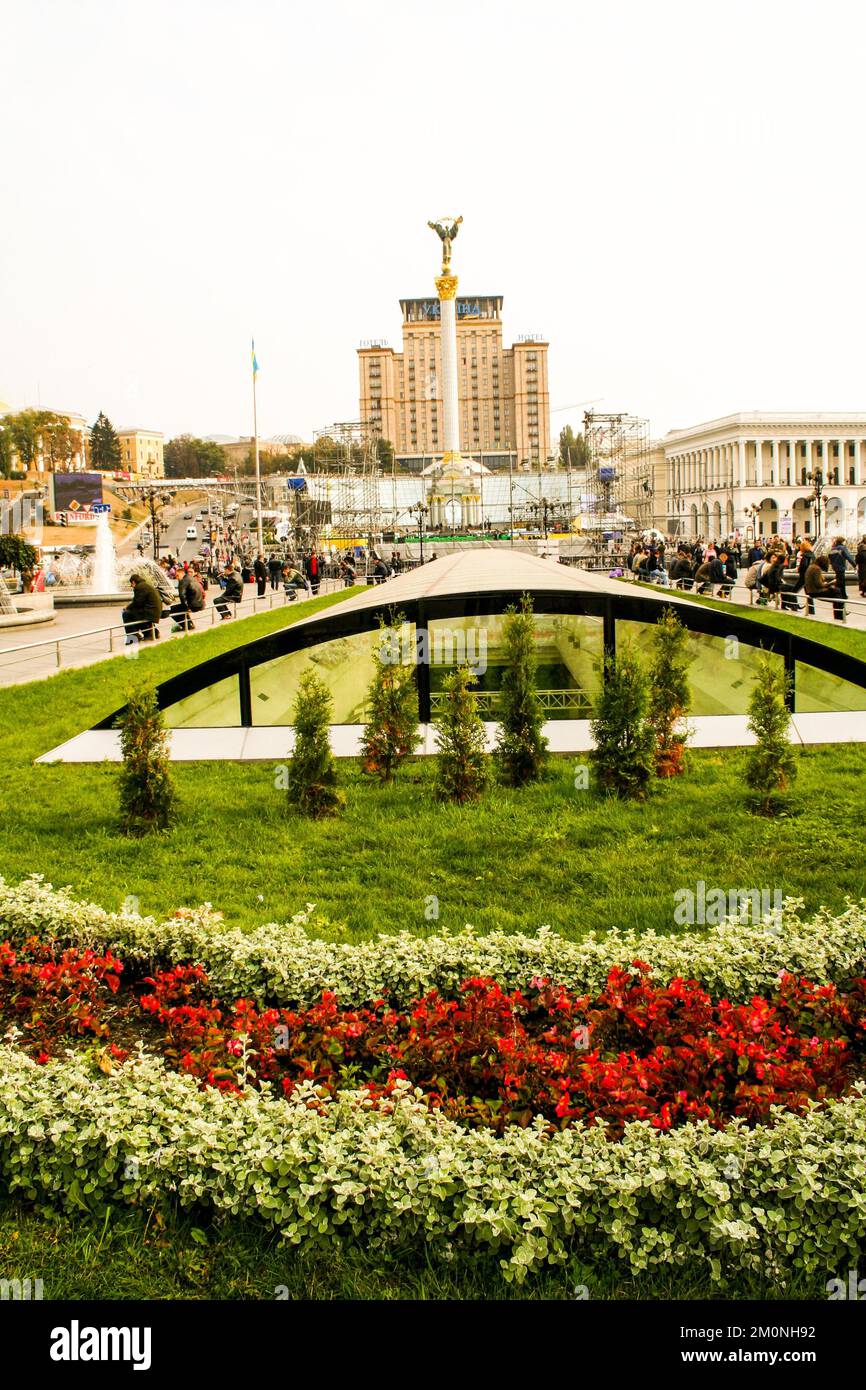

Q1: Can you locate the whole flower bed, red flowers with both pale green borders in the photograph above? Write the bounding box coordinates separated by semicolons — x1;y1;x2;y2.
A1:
0;880;866;1289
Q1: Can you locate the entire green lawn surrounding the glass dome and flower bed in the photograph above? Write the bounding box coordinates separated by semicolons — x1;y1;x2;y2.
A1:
0;595;866;1298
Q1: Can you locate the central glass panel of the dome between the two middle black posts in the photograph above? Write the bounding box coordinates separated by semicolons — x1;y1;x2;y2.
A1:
430;613;603;719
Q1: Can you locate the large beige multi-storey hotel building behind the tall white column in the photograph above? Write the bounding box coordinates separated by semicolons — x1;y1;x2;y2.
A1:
359;295;550;466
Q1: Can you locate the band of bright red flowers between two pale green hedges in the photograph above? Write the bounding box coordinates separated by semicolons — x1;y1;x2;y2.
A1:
0;938;866;1137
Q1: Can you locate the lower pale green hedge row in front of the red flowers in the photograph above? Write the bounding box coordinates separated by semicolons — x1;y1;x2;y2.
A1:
0;1045;866;1290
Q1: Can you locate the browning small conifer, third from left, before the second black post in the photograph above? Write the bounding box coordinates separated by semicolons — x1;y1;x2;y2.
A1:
361;614;421;783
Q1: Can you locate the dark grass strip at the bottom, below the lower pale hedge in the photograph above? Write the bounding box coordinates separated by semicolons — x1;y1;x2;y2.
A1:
0;1200;831;1301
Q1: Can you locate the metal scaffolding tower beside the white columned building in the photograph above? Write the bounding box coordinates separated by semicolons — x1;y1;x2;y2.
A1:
584;410;653;559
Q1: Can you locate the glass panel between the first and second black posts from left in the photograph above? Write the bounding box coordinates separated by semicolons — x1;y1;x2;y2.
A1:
250;623;414;724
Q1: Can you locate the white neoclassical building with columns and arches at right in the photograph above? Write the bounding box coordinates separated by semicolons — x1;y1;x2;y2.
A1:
663;410;866;539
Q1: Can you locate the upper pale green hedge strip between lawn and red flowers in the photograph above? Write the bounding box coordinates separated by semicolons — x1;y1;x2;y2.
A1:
0;878;866;1008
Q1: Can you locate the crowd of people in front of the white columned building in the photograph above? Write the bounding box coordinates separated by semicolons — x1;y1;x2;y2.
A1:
624;535;866;623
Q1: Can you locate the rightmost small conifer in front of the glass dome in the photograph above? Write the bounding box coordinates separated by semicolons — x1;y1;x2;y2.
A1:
745;652;796;816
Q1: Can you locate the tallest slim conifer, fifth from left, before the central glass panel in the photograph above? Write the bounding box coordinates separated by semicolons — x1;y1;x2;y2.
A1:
496;594;548;787
